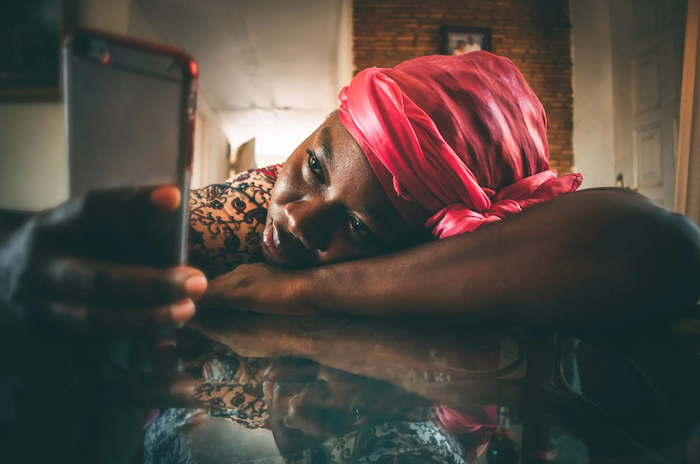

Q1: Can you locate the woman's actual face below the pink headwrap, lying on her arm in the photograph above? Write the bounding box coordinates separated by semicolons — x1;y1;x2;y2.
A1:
263;113;416;268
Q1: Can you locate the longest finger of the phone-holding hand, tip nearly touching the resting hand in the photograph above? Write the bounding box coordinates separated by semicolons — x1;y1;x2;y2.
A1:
40;258;207;307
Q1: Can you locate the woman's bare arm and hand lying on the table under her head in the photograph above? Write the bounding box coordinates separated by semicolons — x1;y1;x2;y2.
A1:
205;189;700;326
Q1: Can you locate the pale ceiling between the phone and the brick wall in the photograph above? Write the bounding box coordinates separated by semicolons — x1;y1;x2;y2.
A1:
135;0;343;113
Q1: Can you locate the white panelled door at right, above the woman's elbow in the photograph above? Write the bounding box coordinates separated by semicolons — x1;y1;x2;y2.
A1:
610;0;686;209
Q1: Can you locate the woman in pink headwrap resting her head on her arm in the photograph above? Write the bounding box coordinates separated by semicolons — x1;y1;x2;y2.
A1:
0;52;700;338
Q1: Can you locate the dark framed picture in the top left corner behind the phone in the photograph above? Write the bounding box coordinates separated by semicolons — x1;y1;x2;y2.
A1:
0;0;77;102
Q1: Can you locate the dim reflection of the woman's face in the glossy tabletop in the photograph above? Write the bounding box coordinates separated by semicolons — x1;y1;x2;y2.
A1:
264;361;419;456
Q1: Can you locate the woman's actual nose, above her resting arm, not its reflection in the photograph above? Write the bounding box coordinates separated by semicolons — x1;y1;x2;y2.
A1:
284;198;331;251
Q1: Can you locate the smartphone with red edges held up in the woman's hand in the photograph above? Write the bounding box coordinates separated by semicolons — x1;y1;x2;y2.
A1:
63;31;197;266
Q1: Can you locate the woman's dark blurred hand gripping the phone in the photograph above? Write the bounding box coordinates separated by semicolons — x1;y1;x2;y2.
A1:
0;186;207;335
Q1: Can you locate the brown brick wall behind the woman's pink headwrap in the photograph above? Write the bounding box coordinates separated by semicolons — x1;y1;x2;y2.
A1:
353;0;573;174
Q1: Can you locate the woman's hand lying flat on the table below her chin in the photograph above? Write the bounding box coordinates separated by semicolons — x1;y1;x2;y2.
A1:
197;263;318;316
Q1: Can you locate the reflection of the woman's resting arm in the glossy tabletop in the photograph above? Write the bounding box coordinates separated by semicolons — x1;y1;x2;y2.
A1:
188;312;500;390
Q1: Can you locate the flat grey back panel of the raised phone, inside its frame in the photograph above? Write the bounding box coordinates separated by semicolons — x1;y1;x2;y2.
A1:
68;42;186;196
